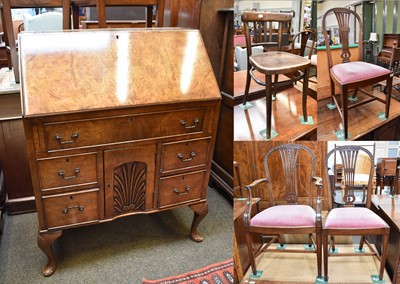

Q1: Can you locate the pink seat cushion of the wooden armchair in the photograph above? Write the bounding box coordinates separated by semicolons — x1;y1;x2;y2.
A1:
250;205;315;227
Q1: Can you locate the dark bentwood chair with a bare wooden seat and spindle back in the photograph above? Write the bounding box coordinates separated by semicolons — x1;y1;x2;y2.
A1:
242;12;310;139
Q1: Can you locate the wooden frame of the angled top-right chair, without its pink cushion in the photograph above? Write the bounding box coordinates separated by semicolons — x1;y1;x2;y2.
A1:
322;8;393;139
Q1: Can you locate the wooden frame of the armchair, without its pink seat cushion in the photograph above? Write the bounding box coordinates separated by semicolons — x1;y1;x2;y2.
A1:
243;144;322;277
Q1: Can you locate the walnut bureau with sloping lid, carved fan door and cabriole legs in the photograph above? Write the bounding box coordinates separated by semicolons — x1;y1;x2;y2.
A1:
19;29;221;276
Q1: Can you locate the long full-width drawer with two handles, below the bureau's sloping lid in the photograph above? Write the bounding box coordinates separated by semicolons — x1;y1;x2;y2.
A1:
43;107;206;151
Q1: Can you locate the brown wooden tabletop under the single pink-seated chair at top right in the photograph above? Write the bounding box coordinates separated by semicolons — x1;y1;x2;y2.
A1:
318;86;400;141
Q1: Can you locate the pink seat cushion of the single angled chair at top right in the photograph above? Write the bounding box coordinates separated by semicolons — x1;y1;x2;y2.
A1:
331;61;391;85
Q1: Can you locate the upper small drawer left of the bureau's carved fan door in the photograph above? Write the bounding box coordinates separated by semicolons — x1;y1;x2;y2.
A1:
37;153;97;190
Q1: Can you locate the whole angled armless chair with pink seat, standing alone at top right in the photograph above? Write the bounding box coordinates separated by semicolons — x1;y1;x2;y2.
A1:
322;8;393;139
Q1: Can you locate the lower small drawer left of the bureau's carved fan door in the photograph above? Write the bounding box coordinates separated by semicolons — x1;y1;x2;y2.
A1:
42;188;99;228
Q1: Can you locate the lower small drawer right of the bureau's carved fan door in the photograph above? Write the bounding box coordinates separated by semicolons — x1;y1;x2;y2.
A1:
158;170;206;208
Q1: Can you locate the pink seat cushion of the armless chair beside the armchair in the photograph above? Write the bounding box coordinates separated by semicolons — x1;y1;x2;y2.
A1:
324;207;389;229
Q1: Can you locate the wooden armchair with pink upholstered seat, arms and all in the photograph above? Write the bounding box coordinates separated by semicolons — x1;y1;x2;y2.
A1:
243;144;322;277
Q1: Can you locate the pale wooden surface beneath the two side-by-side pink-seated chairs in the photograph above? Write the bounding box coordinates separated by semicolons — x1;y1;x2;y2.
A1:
241;245;392;284
